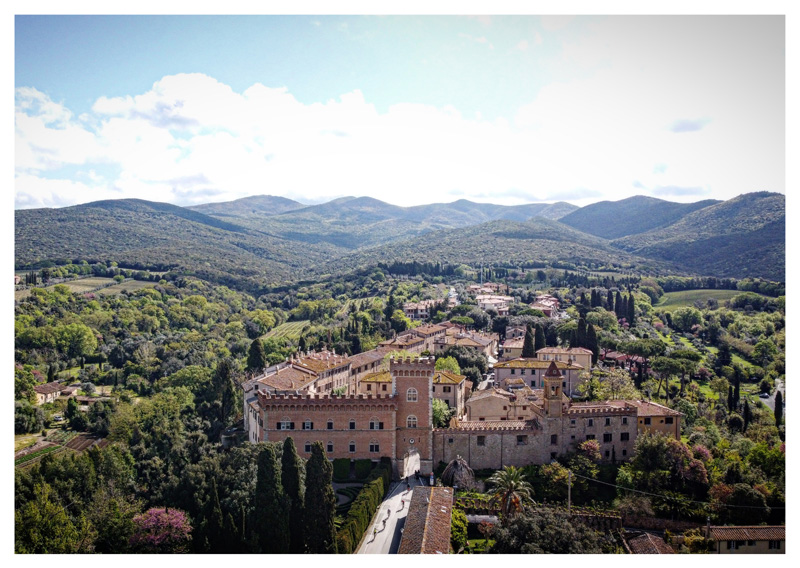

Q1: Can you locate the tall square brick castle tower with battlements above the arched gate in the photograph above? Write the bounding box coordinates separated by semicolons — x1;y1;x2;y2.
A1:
389;357;434;477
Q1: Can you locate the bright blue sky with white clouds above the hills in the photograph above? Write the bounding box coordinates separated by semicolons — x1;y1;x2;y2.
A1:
14;11;786;209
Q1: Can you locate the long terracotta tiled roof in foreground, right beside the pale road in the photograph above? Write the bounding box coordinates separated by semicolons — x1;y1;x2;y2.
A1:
397;487;453;554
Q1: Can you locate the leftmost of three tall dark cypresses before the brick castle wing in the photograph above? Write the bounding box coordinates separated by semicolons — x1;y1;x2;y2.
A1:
255;444;290;554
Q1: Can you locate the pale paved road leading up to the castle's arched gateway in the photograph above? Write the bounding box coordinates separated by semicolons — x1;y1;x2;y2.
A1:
358;454;425;554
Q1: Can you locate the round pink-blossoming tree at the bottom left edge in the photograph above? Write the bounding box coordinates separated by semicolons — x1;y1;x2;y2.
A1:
130;508;192;553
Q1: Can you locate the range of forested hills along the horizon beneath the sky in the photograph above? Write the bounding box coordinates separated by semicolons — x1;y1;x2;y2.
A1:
15;192;786;285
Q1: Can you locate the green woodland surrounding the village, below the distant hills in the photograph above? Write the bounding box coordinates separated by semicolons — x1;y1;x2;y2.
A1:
14;252;785;552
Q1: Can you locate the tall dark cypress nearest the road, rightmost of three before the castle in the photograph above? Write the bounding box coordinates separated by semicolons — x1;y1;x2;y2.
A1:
303;441;336;554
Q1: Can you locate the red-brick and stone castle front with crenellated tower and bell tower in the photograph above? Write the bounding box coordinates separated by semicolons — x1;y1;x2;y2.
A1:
245;357;680;477
